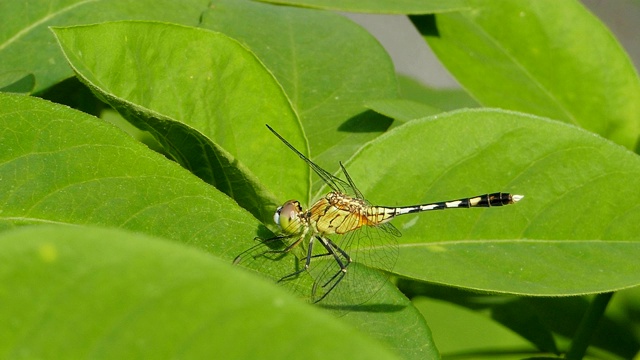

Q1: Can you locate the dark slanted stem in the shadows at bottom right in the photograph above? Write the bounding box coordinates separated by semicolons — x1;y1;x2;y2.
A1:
566;292;613;360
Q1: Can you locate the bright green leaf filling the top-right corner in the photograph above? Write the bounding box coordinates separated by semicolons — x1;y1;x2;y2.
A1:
412;0;640;149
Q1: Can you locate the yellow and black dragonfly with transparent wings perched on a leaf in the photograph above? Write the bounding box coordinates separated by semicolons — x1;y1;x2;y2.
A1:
234;125;524;306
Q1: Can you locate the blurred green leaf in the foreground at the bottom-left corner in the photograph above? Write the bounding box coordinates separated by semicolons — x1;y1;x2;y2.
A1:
0;226;394;359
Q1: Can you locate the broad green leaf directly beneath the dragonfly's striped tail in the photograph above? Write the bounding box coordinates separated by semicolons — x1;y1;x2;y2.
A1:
348;110;640;295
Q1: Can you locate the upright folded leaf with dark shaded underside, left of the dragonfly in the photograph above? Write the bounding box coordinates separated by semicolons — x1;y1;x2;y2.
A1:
54;22;309;223
